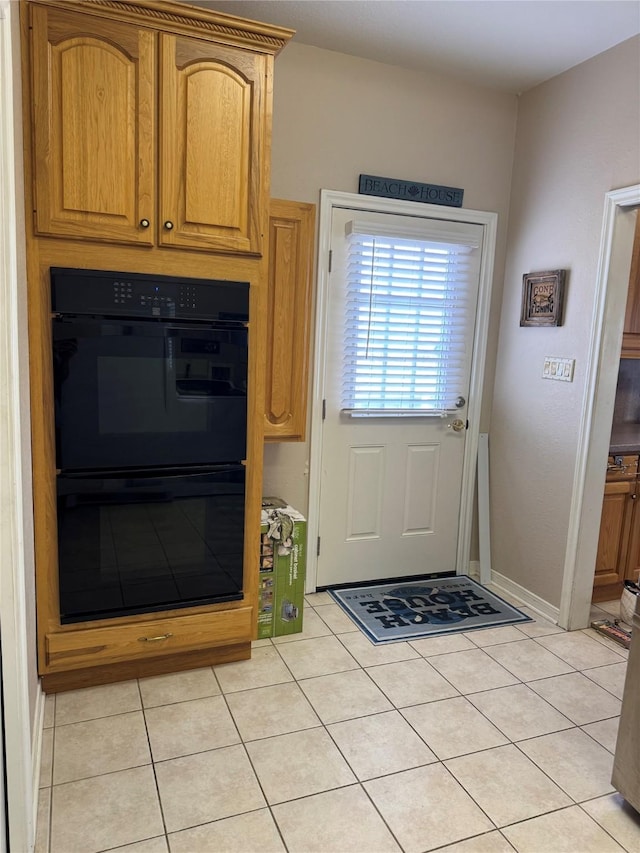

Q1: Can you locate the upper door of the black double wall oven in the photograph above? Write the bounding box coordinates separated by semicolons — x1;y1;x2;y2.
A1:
53;317;247;471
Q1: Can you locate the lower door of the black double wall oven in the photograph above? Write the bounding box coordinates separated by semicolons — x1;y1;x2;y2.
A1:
57;464;245;624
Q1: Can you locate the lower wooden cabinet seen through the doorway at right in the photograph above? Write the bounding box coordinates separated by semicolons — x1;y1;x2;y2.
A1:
592;454;640;602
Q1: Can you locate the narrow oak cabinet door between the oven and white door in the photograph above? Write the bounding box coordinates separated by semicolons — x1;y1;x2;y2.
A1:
265;199;315;441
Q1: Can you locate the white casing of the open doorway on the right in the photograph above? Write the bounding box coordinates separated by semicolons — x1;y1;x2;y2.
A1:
558;184;640;631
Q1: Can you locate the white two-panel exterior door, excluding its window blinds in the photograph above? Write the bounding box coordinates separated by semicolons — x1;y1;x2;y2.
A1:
316;208;483;587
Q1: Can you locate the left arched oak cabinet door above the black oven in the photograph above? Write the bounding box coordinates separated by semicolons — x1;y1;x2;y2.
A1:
32;6;155;245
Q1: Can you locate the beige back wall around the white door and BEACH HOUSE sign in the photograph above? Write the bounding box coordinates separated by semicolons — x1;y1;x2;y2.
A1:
264;40;517;513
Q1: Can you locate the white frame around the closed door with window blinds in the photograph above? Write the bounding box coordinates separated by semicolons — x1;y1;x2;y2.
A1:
306;190;498;592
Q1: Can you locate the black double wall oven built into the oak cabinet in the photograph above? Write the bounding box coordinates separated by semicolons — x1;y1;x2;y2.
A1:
51;267;249;624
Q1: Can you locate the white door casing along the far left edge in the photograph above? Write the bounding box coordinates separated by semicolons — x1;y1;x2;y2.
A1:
0;0;40;853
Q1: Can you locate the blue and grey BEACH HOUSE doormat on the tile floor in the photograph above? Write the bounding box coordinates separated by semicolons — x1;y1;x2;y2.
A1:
327;575;533;643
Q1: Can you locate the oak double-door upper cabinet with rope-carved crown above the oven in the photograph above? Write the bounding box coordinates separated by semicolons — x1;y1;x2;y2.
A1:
30;0;290;255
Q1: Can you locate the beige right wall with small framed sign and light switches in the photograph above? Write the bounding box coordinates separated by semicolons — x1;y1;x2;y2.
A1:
490;38;640;607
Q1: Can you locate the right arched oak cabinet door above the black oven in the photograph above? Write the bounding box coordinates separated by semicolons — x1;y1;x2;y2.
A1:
160;35;271;255
